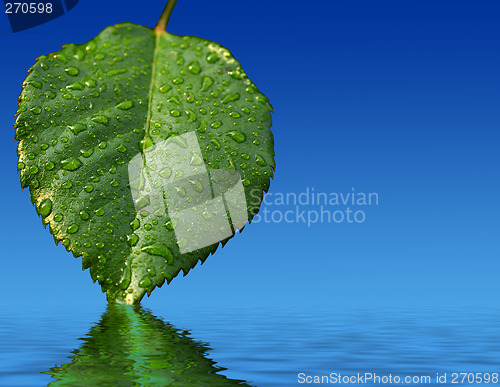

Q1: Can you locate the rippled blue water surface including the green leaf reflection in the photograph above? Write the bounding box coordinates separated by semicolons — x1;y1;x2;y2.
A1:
0;306;500;386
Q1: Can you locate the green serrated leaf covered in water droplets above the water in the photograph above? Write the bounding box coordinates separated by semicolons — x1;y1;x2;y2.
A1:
15;23;275;304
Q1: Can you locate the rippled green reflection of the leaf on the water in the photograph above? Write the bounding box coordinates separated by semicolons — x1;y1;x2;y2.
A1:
44;305;252;387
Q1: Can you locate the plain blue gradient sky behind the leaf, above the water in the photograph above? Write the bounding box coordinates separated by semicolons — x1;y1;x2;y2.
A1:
0;0;500;310
